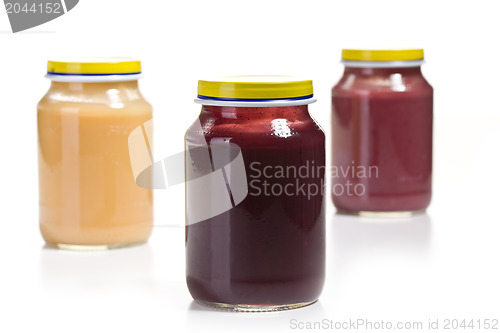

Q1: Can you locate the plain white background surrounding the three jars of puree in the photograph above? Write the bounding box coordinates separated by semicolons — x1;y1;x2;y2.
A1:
0;0;500;332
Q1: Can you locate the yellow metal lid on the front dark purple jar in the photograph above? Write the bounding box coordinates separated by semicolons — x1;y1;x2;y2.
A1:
198;75;313;102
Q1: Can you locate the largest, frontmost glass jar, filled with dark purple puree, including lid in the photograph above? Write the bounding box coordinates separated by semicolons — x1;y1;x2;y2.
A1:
185;76;325;311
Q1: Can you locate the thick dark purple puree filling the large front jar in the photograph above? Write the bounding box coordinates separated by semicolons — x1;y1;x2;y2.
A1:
186;105;325;305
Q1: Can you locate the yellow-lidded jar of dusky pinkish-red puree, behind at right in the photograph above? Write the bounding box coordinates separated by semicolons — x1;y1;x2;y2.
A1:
331;49;433;216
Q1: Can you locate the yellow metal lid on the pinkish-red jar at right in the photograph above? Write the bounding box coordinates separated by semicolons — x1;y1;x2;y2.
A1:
342;49;424;61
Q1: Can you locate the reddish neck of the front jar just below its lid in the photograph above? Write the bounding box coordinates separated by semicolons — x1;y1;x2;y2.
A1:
201;105;310;121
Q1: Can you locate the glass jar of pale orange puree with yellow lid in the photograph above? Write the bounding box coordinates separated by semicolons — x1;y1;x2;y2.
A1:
38;58;153;249
